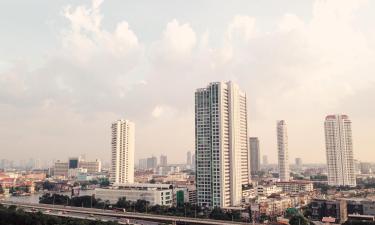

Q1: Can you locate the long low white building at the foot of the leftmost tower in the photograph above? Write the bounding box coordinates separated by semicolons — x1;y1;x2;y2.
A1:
95;183;173;206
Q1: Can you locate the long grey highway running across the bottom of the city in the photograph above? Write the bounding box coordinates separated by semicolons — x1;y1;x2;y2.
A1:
0;201;256;225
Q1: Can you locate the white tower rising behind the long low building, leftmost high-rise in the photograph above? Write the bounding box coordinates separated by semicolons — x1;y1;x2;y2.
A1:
110;120;135;184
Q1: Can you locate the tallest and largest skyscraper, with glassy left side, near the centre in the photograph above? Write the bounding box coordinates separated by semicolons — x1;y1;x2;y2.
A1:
195;82;250;207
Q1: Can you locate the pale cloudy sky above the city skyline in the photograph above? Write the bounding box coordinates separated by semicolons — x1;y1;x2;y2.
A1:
0;0;375;163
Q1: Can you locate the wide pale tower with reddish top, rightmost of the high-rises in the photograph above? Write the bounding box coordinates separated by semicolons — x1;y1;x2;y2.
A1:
324;115;356;186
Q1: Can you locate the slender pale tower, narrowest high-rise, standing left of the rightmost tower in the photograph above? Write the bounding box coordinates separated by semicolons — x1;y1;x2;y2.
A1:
277;120;290;181
